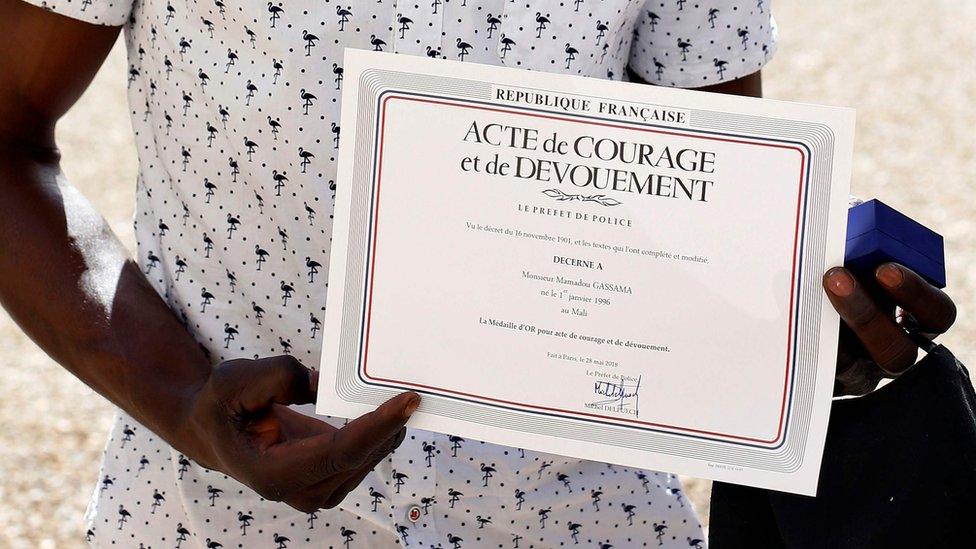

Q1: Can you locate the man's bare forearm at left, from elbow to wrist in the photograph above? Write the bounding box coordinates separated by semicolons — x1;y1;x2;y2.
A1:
0;142;210;459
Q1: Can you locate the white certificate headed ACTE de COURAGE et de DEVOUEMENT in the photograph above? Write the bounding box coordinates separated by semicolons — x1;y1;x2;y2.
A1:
317;50;854;495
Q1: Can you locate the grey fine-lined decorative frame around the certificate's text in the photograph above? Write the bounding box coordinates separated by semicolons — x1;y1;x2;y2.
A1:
336;69;834;473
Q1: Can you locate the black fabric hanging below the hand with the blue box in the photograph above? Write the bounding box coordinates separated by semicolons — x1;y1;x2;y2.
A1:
709;346;976;549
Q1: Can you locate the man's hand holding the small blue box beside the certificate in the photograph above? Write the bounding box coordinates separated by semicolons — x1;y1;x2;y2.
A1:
823;263;956;395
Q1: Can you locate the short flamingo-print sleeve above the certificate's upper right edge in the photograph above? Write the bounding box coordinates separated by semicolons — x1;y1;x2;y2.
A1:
629;0;776;88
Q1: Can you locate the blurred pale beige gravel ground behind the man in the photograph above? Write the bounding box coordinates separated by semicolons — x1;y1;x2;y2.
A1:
0;0;976;549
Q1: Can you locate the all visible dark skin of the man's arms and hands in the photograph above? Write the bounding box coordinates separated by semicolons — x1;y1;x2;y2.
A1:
0;0;955;512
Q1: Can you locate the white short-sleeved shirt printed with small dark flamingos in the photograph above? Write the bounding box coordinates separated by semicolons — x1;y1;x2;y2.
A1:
29;0;776;549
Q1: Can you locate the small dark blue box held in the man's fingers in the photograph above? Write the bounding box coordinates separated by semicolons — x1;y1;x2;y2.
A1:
844;199;946;288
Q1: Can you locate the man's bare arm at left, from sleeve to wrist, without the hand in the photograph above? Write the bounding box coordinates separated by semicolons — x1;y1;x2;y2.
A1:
0;0;210;446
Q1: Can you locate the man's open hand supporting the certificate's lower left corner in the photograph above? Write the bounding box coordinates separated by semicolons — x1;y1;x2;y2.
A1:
188;355;420;513
